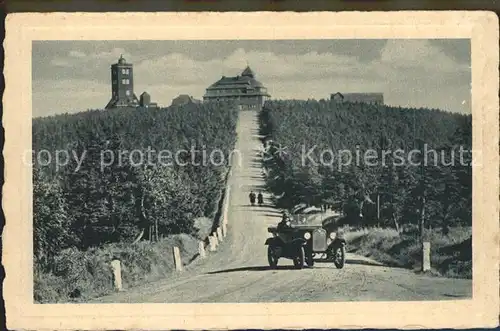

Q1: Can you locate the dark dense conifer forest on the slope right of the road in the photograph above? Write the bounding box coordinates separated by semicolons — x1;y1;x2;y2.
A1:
260;100;472;232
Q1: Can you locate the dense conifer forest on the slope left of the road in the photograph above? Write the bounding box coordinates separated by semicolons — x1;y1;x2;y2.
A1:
33;103;238;268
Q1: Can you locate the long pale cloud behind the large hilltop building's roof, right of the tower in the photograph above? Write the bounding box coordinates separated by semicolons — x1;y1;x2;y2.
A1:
134;48;364;86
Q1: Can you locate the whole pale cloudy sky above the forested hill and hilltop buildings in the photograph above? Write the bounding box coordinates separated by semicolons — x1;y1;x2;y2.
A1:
32;39;471;117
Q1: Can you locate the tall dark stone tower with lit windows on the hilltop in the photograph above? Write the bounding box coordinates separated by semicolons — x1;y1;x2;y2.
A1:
106;56;139;109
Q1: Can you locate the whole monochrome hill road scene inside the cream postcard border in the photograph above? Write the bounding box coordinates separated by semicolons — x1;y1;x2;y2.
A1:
3;11;498;331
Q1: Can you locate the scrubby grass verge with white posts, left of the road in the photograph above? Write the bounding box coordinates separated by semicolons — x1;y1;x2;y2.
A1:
34;234;202;303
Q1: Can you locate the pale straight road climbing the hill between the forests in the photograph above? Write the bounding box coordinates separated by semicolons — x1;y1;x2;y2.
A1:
94;111;472;303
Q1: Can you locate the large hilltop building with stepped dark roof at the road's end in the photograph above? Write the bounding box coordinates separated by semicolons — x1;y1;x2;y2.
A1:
203;66;270;110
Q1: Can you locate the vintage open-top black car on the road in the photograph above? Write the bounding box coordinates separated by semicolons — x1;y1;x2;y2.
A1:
266;221;346;269
